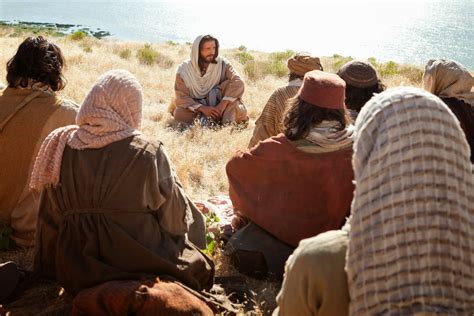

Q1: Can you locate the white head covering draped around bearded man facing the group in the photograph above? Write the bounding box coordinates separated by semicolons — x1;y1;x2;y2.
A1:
177;35;224;99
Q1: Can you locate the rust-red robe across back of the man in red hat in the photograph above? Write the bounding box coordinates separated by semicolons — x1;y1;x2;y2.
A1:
226;134;354;247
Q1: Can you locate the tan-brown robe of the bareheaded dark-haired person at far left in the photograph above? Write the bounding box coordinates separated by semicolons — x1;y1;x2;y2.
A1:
0;88;79;246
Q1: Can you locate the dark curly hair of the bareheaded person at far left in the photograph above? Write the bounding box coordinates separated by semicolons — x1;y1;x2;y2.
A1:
7;36;66;91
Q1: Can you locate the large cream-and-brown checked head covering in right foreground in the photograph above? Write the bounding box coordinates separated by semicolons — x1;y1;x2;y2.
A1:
346;88;474;315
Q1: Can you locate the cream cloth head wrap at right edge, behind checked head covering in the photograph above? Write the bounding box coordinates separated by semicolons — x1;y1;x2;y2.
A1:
423;59;474;106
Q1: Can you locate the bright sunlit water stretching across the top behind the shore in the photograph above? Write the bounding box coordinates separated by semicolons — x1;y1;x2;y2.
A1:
0;0;474;69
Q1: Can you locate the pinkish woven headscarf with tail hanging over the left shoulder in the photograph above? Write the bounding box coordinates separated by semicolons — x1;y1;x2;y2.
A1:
30;69;142;191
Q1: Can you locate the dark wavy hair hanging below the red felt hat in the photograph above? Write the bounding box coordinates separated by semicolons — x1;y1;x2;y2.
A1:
283;96;351;140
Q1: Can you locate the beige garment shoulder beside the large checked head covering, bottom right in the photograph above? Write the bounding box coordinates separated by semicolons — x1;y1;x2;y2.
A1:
273;230;349;316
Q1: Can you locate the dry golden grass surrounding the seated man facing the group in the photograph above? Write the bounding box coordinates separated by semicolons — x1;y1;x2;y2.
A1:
0;29;419;198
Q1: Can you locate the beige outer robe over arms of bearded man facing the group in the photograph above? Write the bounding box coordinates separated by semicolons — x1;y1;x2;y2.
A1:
170;62;248;124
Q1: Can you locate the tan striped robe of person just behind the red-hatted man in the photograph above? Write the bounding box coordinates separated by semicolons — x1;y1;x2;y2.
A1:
248;79;303;148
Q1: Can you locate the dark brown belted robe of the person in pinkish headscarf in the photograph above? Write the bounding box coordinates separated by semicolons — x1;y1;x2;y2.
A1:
35;136;214;294
